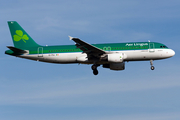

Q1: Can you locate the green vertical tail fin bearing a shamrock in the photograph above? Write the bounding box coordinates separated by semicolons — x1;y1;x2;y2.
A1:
8;21;40;49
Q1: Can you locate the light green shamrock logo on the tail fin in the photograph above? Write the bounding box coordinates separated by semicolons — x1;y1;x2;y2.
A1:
13;30;29;43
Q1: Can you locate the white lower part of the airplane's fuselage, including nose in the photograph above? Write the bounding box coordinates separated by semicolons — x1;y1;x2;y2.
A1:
17;49;175;64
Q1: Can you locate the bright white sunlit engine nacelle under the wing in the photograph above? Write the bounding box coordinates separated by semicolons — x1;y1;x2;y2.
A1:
108;53;124;63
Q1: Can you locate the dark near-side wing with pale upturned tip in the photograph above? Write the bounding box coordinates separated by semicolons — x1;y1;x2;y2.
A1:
69;36;106;58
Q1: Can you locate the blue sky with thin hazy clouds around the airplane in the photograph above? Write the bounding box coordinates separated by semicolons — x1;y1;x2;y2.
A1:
0;0;180;120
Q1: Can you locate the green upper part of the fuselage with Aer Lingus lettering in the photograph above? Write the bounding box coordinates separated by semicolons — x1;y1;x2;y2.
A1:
29;42;167;54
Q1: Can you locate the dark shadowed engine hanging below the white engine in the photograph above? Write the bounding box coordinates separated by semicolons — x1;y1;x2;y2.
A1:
103;62;125;70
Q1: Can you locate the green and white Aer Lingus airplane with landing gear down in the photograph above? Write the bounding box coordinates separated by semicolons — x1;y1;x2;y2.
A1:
5;21;175;75
